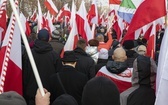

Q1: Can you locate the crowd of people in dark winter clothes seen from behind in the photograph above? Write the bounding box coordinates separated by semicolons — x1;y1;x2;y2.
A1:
0;19;164;105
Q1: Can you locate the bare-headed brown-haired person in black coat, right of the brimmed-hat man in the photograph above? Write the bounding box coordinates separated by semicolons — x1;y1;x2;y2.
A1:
74;39;95;79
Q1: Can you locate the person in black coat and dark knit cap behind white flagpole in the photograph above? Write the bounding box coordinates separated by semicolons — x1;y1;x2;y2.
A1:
23;29;62;105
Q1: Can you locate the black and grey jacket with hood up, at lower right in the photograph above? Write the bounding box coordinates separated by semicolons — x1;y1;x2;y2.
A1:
120;55;156;105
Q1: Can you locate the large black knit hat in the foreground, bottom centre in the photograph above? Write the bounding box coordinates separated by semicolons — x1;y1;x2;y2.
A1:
82;77;120;105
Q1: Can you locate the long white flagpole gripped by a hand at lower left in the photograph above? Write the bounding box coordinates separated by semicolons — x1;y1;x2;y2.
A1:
9;0;45;96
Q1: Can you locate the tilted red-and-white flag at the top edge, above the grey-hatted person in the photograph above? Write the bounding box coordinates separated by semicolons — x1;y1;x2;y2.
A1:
44;0;58;16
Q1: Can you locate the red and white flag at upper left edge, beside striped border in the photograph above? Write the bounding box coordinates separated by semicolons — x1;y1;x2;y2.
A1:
0;0;7;44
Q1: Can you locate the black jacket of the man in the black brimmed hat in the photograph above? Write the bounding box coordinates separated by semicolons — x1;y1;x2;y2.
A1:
49;66;88;105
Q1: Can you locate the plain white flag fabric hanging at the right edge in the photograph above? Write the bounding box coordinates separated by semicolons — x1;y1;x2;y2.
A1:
155;27;168;105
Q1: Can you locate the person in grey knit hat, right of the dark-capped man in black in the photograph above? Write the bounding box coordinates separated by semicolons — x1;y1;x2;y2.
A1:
49;30;64;55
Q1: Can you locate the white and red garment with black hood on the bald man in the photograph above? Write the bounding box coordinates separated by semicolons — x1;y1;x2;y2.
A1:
96;61;132;93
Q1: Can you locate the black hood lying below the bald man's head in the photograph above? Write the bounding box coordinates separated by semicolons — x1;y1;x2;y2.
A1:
106;61;128;74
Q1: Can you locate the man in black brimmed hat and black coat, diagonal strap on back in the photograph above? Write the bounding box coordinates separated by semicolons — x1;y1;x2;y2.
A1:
49;51;88;105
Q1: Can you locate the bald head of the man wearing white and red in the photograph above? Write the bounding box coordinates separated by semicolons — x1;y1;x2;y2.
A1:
112;47;127;62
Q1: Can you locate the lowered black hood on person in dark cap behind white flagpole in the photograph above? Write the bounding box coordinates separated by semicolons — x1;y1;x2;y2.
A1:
33;39;53;53
